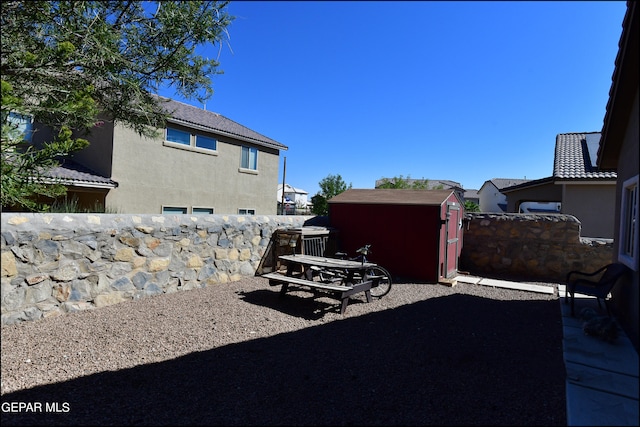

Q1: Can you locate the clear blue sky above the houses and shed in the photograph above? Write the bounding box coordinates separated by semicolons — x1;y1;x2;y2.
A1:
160;1;626;197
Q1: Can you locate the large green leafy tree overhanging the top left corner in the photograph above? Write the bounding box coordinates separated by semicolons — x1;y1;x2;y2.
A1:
0;0;234;210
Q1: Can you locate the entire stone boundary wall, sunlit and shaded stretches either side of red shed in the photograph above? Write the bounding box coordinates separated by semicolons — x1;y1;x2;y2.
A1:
1;213;613;324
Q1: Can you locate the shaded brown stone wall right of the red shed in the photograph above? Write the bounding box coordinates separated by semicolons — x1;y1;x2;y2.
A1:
459;213;613;283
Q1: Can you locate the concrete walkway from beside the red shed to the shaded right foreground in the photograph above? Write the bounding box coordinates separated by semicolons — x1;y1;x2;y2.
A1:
456;275;640;426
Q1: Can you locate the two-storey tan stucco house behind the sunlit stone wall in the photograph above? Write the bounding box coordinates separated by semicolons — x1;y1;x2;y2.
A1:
31;98;287;215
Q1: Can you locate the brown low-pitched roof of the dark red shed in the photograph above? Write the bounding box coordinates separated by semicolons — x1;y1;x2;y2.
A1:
328;188;455;206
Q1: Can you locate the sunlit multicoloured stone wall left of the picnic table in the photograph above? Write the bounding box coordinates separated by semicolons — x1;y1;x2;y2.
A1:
1;213;311;324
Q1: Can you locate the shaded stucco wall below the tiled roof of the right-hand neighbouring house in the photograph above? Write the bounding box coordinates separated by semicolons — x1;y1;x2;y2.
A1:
559;182;616;239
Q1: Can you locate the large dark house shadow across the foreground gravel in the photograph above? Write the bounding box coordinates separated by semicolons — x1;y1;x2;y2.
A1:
1;294;566;426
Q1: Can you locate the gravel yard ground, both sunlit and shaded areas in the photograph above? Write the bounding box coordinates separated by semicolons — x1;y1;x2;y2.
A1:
1;277;566;426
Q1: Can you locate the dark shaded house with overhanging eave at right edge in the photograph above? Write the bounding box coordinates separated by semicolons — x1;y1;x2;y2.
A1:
597;1;640;351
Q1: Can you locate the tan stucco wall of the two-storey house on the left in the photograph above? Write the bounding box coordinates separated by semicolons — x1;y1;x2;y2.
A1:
107;126;279;215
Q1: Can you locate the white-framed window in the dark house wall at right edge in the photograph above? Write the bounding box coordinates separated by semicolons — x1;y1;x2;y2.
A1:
618;175;638;270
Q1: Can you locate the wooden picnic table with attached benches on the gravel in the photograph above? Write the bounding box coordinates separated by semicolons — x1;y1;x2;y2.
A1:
262;255;376;314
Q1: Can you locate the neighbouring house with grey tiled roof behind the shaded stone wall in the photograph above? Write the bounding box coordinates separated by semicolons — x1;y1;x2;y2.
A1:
501;132;616;239
